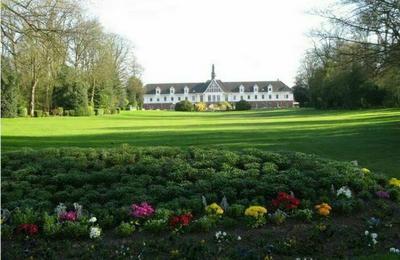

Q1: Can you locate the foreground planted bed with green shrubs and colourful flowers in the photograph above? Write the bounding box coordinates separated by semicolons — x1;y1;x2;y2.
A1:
2;146;400;258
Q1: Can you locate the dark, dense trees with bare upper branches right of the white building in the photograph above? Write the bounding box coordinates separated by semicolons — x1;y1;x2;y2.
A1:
293;0;400;109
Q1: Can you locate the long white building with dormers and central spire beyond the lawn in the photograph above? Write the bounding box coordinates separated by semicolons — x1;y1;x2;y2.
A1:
143;65;294;109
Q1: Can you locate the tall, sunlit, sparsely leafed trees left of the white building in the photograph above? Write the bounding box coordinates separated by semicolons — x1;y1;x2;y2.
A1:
1;0;143;117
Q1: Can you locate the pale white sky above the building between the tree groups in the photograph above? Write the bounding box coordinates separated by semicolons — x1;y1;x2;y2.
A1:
89;0;324;87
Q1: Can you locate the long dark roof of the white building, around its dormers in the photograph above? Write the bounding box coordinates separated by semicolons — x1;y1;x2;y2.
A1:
144;80;291;94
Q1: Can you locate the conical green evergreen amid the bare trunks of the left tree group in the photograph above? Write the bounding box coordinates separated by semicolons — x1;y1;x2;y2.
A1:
52;66;89;116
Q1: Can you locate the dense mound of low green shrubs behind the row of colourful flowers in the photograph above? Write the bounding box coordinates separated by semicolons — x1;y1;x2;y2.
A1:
1;145;388;216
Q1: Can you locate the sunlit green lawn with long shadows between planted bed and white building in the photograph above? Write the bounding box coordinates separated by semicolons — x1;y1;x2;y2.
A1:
2;109;400;177
